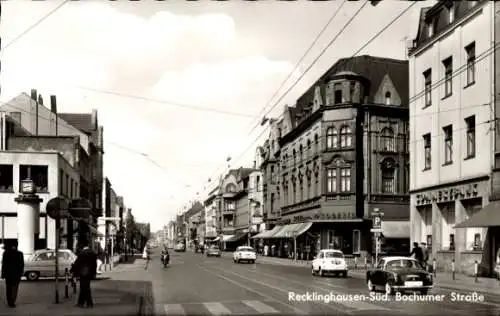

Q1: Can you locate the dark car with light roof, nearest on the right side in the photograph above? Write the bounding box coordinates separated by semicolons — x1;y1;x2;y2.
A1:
366;257;433;295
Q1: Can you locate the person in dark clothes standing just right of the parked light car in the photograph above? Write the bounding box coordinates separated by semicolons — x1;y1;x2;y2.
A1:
72;243;97;307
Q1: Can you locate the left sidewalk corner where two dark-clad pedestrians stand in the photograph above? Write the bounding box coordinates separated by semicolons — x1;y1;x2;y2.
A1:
0;260;152;316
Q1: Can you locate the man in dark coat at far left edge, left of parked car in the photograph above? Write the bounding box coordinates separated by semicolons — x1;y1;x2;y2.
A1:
2;242;24;307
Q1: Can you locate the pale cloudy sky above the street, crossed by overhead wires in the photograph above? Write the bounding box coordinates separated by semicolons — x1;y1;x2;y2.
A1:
0;0;434;230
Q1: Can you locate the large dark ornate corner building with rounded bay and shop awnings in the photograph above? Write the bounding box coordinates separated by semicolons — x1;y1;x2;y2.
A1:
256;55;409;258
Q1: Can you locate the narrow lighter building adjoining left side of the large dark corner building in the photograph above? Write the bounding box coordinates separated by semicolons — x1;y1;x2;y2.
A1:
257;119;282;230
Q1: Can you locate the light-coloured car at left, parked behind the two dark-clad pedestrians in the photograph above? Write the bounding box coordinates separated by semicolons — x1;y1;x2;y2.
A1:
24;249;76;281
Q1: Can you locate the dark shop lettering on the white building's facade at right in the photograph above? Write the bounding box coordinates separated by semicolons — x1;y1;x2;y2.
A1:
417;183;478;205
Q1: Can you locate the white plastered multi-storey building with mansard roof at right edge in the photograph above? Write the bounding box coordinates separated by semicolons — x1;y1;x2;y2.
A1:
409;1;500;273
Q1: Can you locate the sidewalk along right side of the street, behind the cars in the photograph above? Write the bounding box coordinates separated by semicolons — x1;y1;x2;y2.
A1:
250;253;500;295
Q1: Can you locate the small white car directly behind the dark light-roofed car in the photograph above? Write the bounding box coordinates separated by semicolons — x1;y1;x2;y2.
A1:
311;249;348;278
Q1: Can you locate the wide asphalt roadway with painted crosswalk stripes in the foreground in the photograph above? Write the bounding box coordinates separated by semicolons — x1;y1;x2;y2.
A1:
148;251;500;315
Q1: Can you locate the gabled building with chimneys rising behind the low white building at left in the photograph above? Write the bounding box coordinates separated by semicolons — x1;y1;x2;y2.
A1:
0;89;104;247
